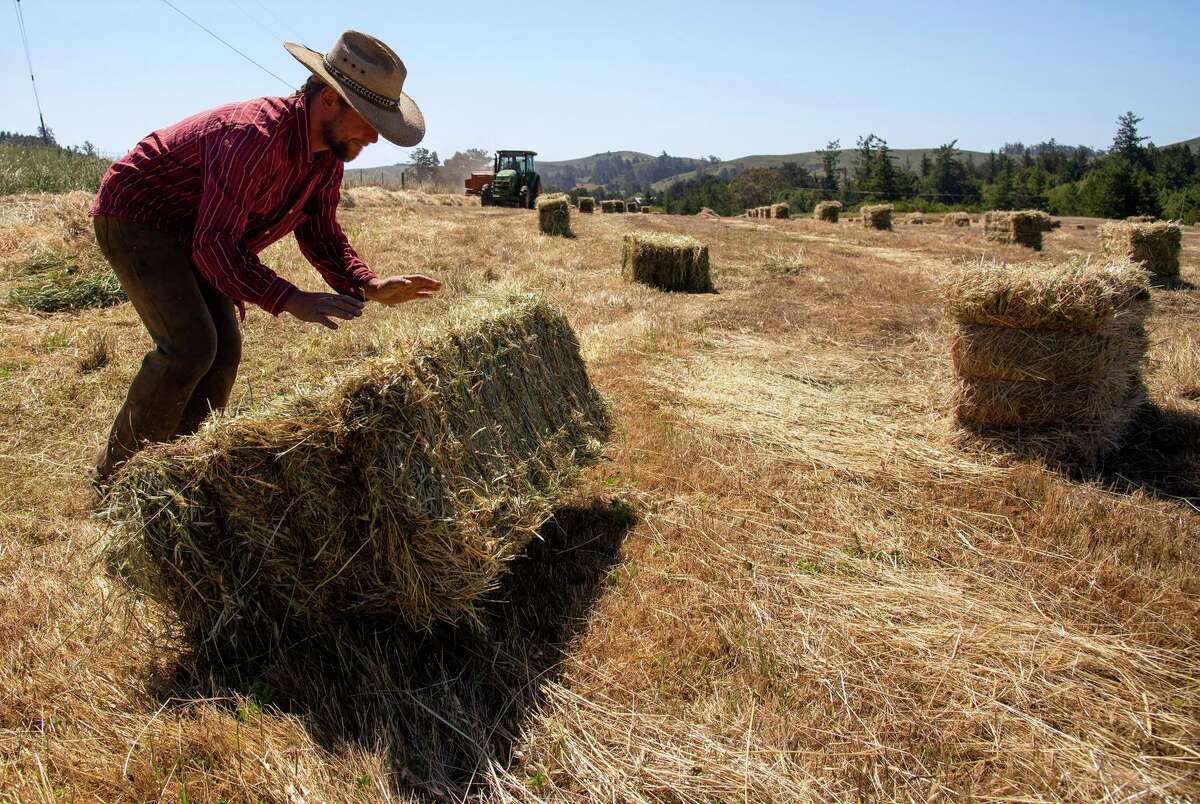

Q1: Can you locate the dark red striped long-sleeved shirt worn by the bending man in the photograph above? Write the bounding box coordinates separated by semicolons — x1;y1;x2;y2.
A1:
91;97;376;316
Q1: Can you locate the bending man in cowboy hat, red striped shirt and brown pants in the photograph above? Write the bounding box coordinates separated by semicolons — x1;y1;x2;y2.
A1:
91;31;440;488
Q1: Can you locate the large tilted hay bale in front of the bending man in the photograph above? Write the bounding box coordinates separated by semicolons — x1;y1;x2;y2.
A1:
108;296;610;647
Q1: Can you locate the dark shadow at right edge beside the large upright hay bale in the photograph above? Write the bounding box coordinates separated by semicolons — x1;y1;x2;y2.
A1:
1094;404;1200;506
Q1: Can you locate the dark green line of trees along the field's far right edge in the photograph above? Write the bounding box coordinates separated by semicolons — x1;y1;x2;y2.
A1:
572;112;1200;223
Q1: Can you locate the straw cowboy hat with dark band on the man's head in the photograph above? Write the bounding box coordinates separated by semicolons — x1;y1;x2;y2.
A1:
283;31;425;148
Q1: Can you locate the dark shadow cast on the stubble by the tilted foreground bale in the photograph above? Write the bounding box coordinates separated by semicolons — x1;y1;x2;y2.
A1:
161;500;635;799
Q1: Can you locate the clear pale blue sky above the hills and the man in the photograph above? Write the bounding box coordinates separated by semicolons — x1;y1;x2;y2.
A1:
7;0;1200;167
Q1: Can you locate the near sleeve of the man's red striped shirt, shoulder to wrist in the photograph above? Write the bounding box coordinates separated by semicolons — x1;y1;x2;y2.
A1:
192;126;296;316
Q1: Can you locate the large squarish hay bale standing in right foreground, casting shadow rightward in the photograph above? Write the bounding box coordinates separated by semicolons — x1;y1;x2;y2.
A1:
943;260;1150;466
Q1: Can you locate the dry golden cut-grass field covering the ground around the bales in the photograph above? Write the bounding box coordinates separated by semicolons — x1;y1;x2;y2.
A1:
0;194;1200;802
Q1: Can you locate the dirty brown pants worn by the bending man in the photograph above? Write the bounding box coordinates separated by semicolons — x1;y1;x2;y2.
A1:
95;215;241;479
